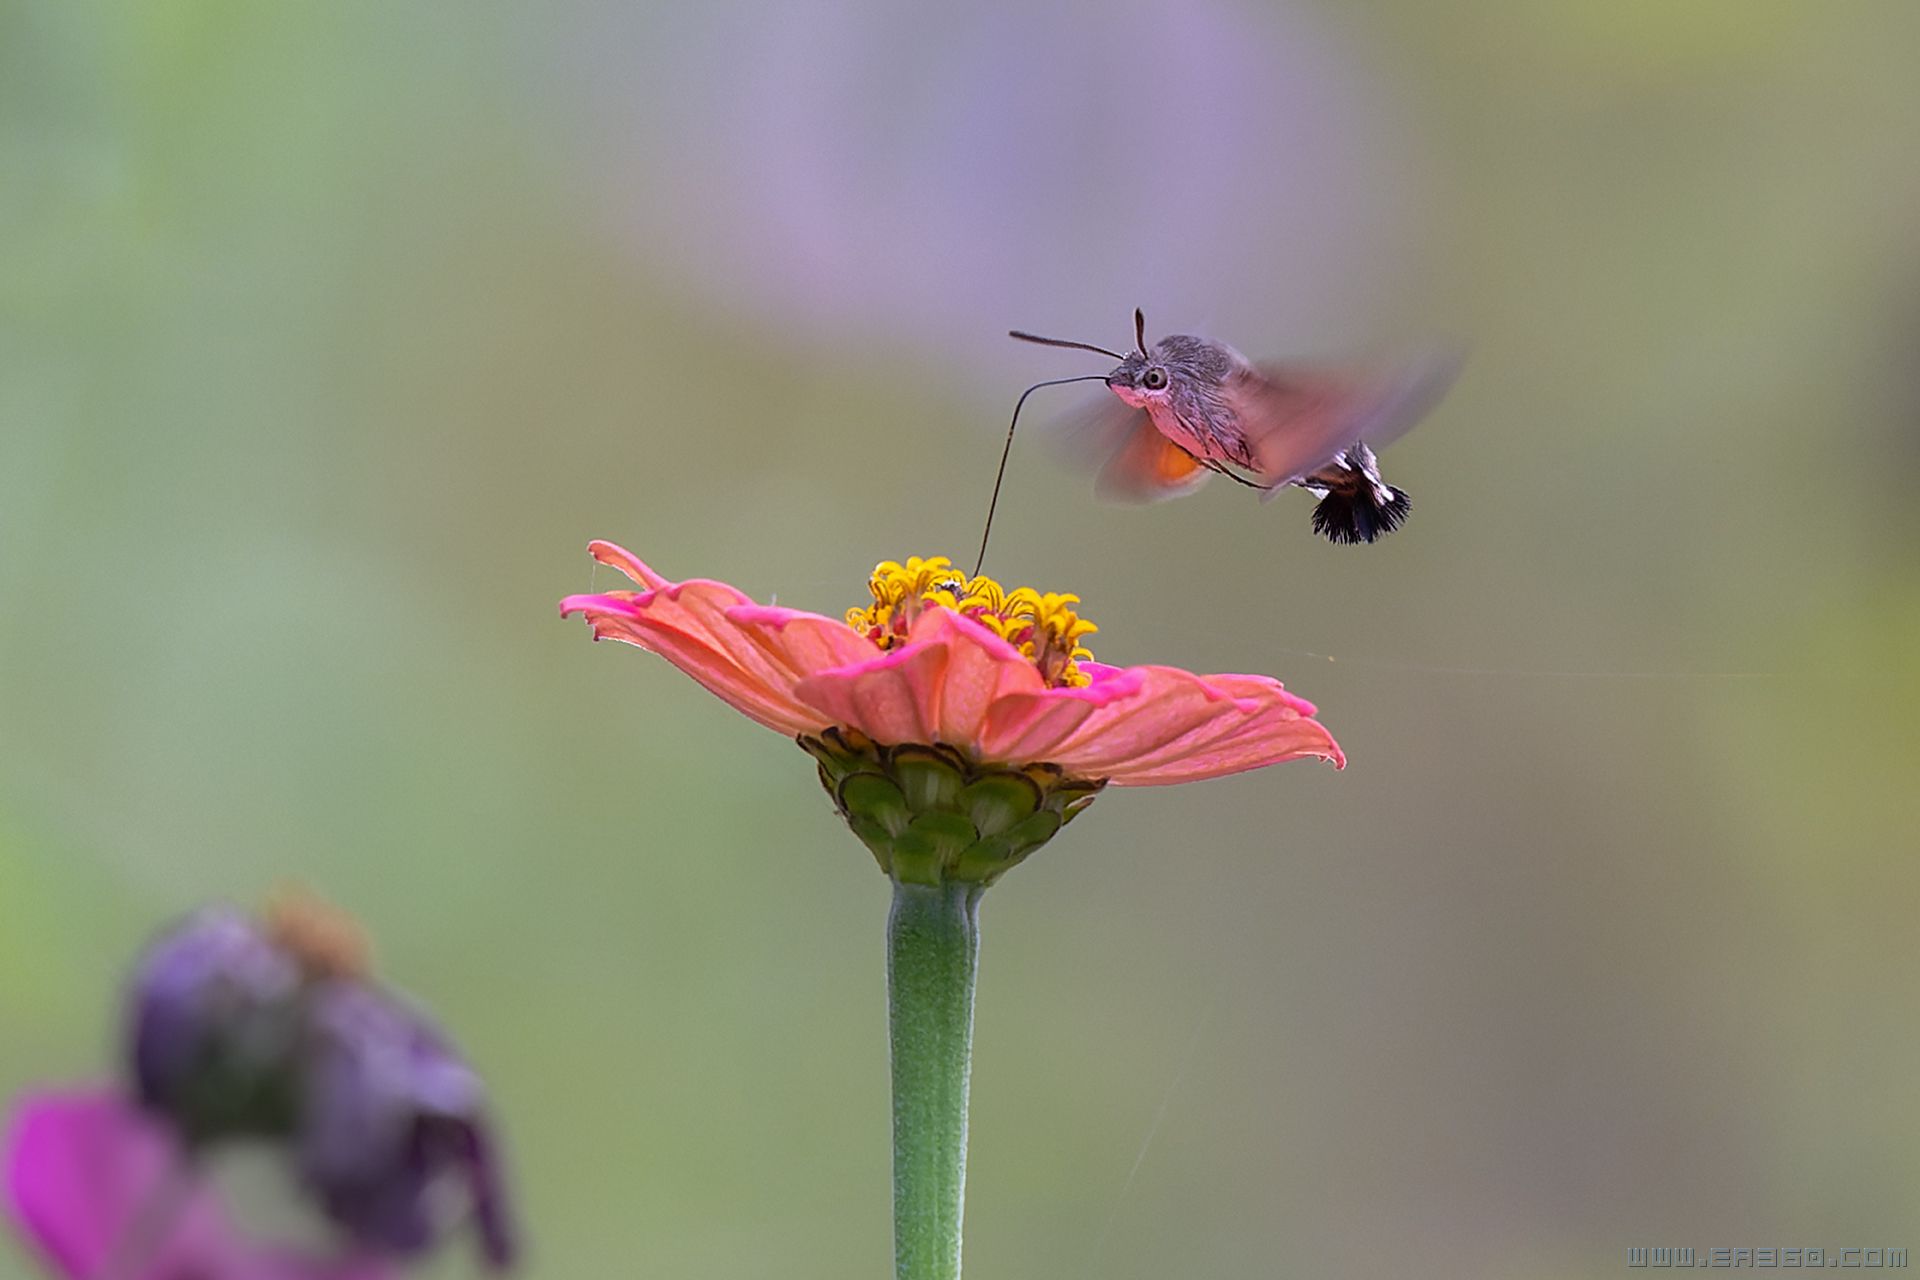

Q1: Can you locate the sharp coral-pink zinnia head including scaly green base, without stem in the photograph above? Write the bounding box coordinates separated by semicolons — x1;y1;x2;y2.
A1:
561;541;1344;883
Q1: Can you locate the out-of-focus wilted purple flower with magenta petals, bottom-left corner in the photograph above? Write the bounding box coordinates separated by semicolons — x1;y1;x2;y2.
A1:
6;898;513;1280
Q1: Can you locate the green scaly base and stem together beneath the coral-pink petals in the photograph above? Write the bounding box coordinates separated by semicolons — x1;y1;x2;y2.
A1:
801;729;1106;1280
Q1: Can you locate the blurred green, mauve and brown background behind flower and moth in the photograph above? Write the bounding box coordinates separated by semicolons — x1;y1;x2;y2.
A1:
0;0;1920;1280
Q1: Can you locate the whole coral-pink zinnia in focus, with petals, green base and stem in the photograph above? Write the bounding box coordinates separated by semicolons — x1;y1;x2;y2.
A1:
561;543;1344;1280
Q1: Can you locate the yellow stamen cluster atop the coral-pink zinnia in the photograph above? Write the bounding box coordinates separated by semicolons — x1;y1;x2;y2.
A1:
847;557;1098;687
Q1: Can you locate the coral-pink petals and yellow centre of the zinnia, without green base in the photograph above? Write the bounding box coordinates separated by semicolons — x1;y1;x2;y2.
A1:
561;541;1344;787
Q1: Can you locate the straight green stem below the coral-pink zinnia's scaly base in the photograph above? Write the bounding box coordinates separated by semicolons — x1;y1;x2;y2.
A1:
887;881;985;1280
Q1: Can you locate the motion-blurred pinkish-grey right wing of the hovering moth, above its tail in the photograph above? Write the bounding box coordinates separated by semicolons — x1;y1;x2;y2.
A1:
1221;349;1461;487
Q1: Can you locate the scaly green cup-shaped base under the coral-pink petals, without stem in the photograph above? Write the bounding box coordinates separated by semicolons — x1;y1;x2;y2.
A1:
801;729;1106;885
